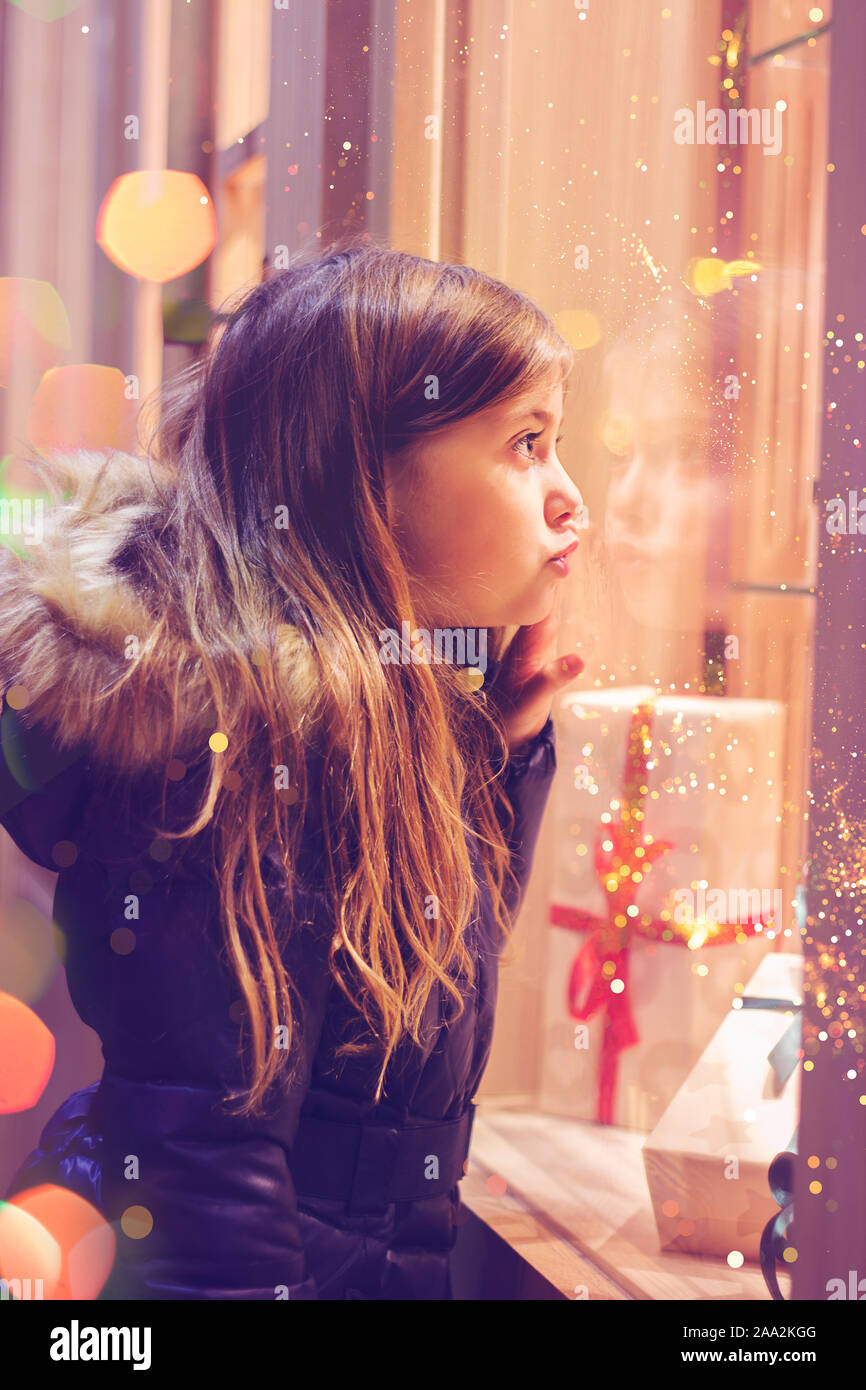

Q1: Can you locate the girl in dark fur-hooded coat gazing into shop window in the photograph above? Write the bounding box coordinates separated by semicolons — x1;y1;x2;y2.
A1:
0;240;582;1300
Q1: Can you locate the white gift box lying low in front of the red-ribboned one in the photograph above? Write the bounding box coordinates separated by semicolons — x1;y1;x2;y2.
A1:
644;951;803;1261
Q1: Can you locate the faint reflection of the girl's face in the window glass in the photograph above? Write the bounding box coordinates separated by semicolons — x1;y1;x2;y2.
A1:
601;344;710;631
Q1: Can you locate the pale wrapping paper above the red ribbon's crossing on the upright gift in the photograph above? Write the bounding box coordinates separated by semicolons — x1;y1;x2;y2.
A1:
550;685;792;922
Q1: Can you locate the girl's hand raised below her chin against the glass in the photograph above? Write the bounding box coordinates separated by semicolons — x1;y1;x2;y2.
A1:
493;589;584;752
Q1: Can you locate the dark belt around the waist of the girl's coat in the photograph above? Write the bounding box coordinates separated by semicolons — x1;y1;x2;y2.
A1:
291;1104;475;1215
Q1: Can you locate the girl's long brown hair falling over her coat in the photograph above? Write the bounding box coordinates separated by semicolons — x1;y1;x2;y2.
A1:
140;236;573;1113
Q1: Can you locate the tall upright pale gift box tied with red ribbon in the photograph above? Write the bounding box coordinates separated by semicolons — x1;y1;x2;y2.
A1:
541;685;788;1131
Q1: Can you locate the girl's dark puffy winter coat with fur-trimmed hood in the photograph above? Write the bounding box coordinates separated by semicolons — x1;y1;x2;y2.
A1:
0;453;555;1300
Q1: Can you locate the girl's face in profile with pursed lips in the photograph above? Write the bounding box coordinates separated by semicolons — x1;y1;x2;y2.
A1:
386;378;582;627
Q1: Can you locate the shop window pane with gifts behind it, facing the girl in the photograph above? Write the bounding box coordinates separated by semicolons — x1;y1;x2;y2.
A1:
461;4;830;1300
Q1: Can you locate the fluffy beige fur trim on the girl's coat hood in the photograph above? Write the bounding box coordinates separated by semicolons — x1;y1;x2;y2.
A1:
0;450;214;771
